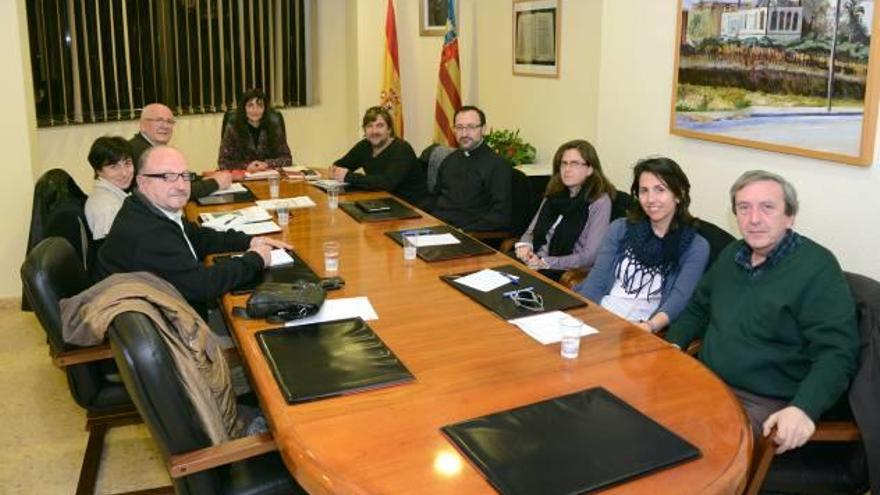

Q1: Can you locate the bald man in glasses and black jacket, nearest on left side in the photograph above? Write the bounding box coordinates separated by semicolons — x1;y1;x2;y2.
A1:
96;146;291;319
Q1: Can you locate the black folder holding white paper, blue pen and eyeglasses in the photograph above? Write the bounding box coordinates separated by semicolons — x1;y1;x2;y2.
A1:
440;265;587;320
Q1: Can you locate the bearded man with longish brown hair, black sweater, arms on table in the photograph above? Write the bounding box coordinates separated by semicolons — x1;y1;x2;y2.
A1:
329;107;428;206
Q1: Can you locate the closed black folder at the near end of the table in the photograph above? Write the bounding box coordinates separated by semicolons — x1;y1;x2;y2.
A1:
441;387;701;495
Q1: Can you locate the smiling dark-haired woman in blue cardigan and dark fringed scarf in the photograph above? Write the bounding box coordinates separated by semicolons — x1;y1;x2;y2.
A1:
577;157;709;332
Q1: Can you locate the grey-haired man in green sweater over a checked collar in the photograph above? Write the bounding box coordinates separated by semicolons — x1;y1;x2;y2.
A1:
667;170;859;453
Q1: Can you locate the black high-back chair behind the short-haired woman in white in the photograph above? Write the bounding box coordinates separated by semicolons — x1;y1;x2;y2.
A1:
21;168;94;311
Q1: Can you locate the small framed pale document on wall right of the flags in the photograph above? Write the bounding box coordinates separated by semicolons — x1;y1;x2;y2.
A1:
513;0;561;77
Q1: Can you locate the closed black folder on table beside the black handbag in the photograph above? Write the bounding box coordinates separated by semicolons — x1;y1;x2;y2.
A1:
257;318;414;404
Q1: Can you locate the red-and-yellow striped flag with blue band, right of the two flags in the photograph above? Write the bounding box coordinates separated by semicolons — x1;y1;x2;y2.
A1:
434;0;461;147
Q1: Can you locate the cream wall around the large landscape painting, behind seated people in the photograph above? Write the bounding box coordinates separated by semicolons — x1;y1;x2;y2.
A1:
598;0;880;278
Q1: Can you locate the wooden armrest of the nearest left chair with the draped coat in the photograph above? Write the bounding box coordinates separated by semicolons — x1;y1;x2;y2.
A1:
168;432;278;478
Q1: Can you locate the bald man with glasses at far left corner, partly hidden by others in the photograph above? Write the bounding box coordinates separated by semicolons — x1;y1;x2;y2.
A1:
128;103;232;199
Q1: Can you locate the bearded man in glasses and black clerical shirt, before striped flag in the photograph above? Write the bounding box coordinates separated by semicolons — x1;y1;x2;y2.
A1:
431;106;513;232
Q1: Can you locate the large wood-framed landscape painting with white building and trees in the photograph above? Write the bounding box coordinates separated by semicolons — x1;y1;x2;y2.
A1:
669;0;880;165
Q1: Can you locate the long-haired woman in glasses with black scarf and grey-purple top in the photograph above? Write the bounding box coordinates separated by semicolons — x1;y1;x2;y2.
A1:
515;139;617;280
